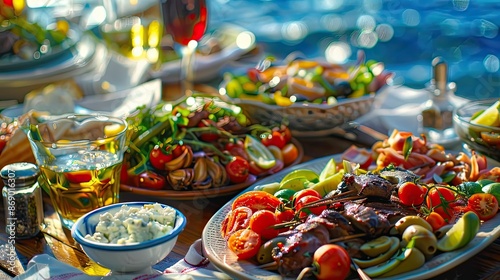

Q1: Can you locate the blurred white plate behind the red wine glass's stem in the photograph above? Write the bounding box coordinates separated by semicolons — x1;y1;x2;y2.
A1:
150;24;255;83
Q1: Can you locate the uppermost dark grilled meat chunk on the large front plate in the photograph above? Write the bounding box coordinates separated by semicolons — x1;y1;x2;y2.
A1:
334;173;396;199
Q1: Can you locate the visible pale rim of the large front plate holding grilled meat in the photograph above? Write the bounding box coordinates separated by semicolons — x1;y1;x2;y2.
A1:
202;155;500;280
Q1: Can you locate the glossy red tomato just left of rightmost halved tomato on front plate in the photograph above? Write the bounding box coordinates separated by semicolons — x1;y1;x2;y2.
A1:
425;187;455;221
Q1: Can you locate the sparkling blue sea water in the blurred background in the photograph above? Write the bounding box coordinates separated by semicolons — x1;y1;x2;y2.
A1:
208;0;500;99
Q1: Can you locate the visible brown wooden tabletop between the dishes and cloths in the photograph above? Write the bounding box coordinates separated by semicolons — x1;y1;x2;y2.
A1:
0;81;500;280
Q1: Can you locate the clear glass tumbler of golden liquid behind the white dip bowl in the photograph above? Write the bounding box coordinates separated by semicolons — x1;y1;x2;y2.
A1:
23;114;128;229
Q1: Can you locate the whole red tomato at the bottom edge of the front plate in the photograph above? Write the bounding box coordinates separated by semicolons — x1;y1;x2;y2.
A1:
313;244;351;280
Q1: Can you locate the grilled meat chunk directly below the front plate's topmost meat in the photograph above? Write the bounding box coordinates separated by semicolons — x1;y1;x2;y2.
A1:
343;202;391;237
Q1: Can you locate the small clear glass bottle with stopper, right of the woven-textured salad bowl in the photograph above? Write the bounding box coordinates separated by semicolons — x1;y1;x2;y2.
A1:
418;57;458;144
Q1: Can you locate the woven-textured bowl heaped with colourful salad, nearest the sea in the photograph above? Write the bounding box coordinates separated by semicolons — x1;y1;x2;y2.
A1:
219;54;392;136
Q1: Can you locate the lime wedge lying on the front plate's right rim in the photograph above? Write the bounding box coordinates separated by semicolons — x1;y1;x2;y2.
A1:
438;211;481;252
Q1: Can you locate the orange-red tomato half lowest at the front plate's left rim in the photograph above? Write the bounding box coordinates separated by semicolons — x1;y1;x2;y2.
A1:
227;228;262;260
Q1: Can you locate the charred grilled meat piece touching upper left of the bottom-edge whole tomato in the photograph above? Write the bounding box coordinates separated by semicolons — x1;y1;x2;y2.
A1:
272;221;331;277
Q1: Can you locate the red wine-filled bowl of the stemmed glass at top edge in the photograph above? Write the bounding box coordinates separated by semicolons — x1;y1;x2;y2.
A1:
162;0;208;46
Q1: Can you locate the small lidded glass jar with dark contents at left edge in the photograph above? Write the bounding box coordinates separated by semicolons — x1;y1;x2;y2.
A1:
0;162;44;240
